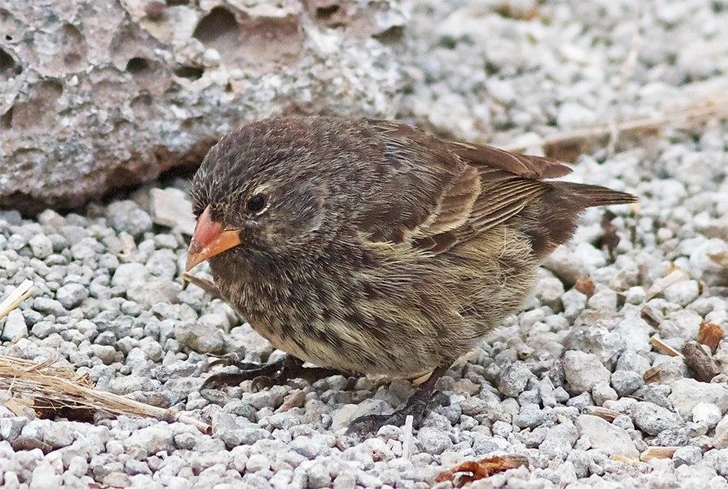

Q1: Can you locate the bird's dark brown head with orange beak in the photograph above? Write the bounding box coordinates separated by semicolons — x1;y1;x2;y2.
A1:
186;118;366;270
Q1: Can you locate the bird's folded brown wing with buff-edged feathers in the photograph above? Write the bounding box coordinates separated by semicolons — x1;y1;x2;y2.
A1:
362;122;571;253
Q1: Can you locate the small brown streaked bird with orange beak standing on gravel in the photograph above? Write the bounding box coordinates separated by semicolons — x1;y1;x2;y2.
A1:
186;117;636;431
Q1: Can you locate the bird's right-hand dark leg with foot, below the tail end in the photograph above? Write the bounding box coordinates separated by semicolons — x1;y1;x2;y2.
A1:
346;364;450;435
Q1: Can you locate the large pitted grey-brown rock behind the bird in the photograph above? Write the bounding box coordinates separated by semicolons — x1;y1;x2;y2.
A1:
0;0;406;212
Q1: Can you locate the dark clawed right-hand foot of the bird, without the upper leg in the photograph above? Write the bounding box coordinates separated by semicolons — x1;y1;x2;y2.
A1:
346;389;447;436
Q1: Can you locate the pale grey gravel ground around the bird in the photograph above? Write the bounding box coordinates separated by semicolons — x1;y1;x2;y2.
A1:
0;0;728;489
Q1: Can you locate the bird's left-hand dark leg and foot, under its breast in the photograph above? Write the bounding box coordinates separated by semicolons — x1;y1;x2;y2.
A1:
200;355;346;390
